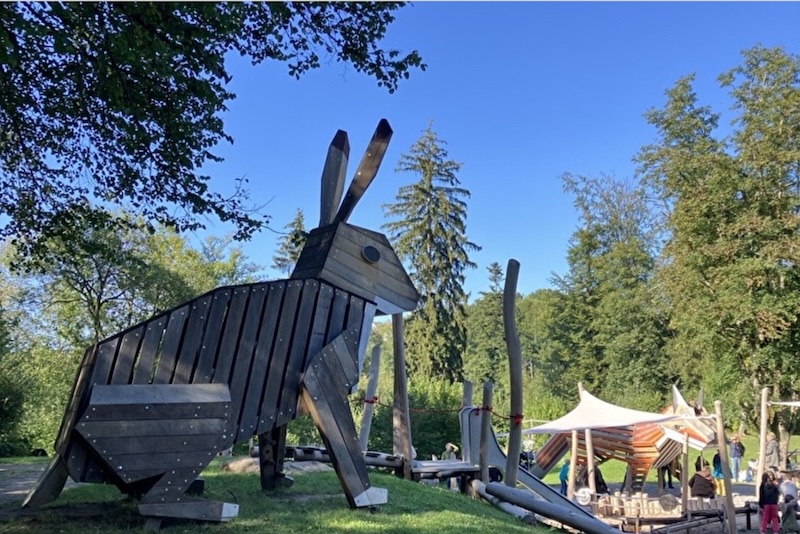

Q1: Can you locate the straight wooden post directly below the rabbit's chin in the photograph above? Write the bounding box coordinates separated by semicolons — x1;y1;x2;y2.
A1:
392;313;414;480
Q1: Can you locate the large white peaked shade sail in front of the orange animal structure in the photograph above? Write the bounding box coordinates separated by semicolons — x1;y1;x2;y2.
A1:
522;389;687;435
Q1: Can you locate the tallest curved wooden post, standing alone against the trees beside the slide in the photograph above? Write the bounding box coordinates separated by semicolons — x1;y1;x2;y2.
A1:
503;260;522;488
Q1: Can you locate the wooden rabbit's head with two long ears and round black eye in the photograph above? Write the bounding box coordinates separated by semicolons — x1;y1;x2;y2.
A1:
292;119;419;314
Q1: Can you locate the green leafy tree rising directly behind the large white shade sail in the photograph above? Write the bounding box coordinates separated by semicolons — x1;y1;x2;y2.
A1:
555;174;671;409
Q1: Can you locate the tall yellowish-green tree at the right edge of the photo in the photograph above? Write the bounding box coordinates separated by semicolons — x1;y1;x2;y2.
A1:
638;46;800;442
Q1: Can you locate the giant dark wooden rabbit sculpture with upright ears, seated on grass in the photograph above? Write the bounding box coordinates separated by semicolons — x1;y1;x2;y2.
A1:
25;120;419;522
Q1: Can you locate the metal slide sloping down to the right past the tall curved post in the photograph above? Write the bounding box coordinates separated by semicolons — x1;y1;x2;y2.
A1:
458;406;605;525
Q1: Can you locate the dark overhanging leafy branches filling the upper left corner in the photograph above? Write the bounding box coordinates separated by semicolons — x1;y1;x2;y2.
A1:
0;2;425;266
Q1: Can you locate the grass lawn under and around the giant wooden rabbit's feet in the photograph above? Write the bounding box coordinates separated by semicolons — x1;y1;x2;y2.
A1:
0;459;556;534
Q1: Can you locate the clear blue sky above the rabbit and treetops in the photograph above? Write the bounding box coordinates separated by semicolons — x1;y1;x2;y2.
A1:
197;2;800;298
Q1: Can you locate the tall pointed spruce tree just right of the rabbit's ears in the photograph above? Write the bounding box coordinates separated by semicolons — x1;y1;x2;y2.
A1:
383;124;480;381
